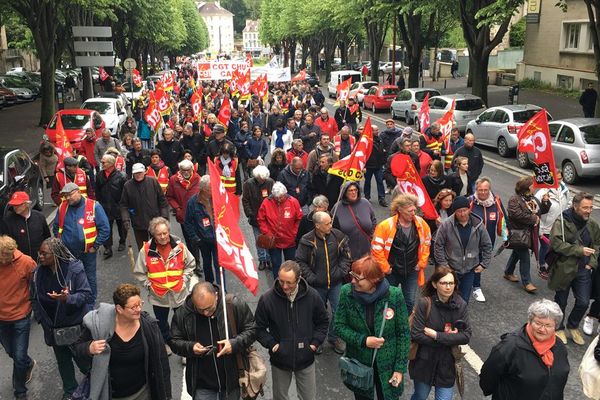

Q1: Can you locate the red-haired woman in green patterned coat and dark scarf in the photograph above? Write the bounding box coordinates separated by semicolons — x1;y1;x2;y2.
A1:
335;256;410;400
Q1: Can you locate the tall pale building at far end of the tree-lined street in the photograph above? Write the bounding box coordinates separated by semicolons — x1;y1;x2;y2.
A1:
196;0;234;56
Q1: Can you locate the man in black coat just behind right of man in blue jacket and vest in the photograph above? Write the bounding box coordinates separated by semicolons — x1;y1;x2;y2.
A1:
96;154;127;260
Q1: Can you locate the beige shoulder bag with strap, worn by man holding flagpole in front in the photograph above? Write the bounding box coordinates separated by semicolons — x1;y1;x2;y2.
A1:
225;294;267;400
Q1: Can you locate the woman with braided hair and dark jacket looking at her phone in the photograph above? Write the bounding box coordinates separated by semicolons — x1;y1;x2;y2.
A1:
31;238;92;399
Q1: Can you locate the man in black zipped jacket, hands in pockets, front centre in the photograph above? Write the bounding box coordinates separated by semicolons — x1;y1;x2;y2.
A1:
256;260;329;399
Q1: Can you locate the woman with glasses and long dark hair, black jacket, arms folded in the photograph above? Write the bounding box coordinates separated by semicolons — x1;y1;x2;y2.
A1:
408;267;471;400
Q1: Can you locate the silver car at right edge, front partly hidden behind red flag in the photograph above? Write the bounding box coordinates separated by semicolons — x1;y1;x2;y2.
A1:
517;118;600;184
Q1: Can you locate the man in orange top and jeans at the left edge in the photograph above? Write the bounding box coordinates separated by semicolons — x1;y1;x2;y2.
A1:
0;236;36;399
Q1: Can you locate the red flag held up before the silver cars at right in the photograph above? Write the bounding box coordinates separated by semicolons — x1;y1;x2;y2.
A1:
517;109;558;189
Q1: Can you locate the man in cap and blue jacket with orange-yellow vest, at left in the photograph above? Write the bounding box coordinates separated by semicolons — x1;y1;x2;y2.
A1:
53;182;110;308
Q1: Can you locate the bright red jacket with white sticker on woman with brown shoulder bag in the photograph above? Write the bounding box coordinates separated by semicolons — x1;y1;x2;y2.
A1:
256;194;302;249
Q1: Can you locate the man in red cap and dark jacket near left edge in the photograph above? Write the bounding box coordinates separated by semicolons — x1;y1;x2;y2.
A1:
0;192;50;260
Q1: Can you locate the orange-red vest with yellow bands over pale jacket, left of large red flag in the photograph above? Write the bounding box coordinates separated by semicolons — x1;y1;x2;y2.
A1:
143;242;185;297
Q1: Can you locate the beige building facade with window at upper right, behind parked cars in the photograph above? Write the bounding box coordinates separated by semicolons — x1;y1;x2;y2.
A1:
517;0;597;90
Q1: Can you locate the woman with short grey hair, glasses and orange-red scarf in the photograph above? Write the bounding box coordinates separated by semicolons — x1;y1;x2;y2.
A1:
479;299;570;400
